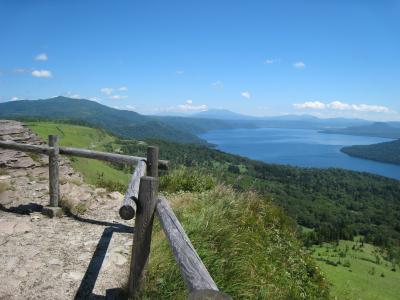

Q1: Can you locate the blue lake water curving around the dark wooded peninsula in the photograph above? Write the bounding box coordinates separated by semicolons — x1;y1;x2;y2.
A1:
200;128;400;179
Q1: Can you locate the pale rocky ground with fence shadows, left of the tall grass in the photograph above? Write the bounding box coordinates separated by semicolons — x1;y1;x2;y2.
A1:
0;120;133;299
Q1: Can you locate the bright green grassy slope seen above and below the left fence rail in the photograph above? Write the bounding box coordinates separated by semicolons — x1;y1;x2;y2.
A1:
28;122;131;190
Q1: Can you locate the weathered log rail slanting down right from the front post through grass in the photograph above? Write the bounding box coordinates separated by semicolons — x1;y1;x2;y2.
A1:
156;197;218;292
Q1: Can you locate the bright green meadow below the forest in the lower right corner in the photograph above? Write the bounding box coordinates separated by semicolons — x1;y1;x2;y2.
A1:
313;240;400;300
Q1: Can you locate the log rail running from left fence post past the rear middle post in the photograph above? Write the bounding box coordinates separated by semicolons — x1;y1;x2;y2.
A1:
60;147;168;169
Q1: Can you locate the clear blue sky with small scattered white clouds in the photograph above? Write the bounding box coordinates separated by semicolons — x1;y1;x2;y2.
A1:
0;0;400;120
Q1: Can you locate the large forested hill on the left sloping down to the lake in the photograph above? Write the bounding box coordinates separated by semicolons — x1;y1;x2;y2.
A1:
0;97;219;143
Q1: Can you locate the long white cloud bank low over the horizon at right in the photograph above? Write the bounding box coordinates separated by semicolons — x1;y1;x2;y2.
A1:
293;101;392;113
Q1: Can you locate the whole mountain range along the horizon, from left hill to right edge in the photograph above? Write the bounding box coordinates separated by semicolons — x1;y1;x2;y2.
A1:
0;97;400;144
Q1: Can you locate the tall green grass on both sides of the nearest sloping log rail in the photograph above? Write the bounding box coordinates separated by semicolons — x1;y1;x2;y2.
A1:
143;185;329;299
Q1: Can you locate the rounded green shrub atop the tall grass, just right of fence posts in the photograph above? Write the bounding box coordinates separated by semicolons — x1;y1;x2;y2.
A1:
160;167;215;193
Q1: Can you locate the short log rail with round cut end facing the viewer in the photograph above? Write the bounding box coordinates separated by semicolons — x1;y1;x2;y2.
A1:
119;160;146;220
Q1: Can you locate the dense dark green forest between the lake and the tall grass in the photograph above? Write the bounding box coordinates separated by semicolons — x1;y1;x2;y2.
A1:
110;140;400;246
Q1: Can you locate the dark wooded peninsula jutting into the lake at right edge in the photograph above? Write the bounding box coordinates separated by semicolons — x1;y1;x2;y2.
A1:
341;140;400;165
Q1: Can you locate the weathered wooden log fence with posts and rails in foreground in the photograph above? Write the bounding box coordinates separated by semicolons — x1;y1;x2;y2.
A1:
0;135;232;300
